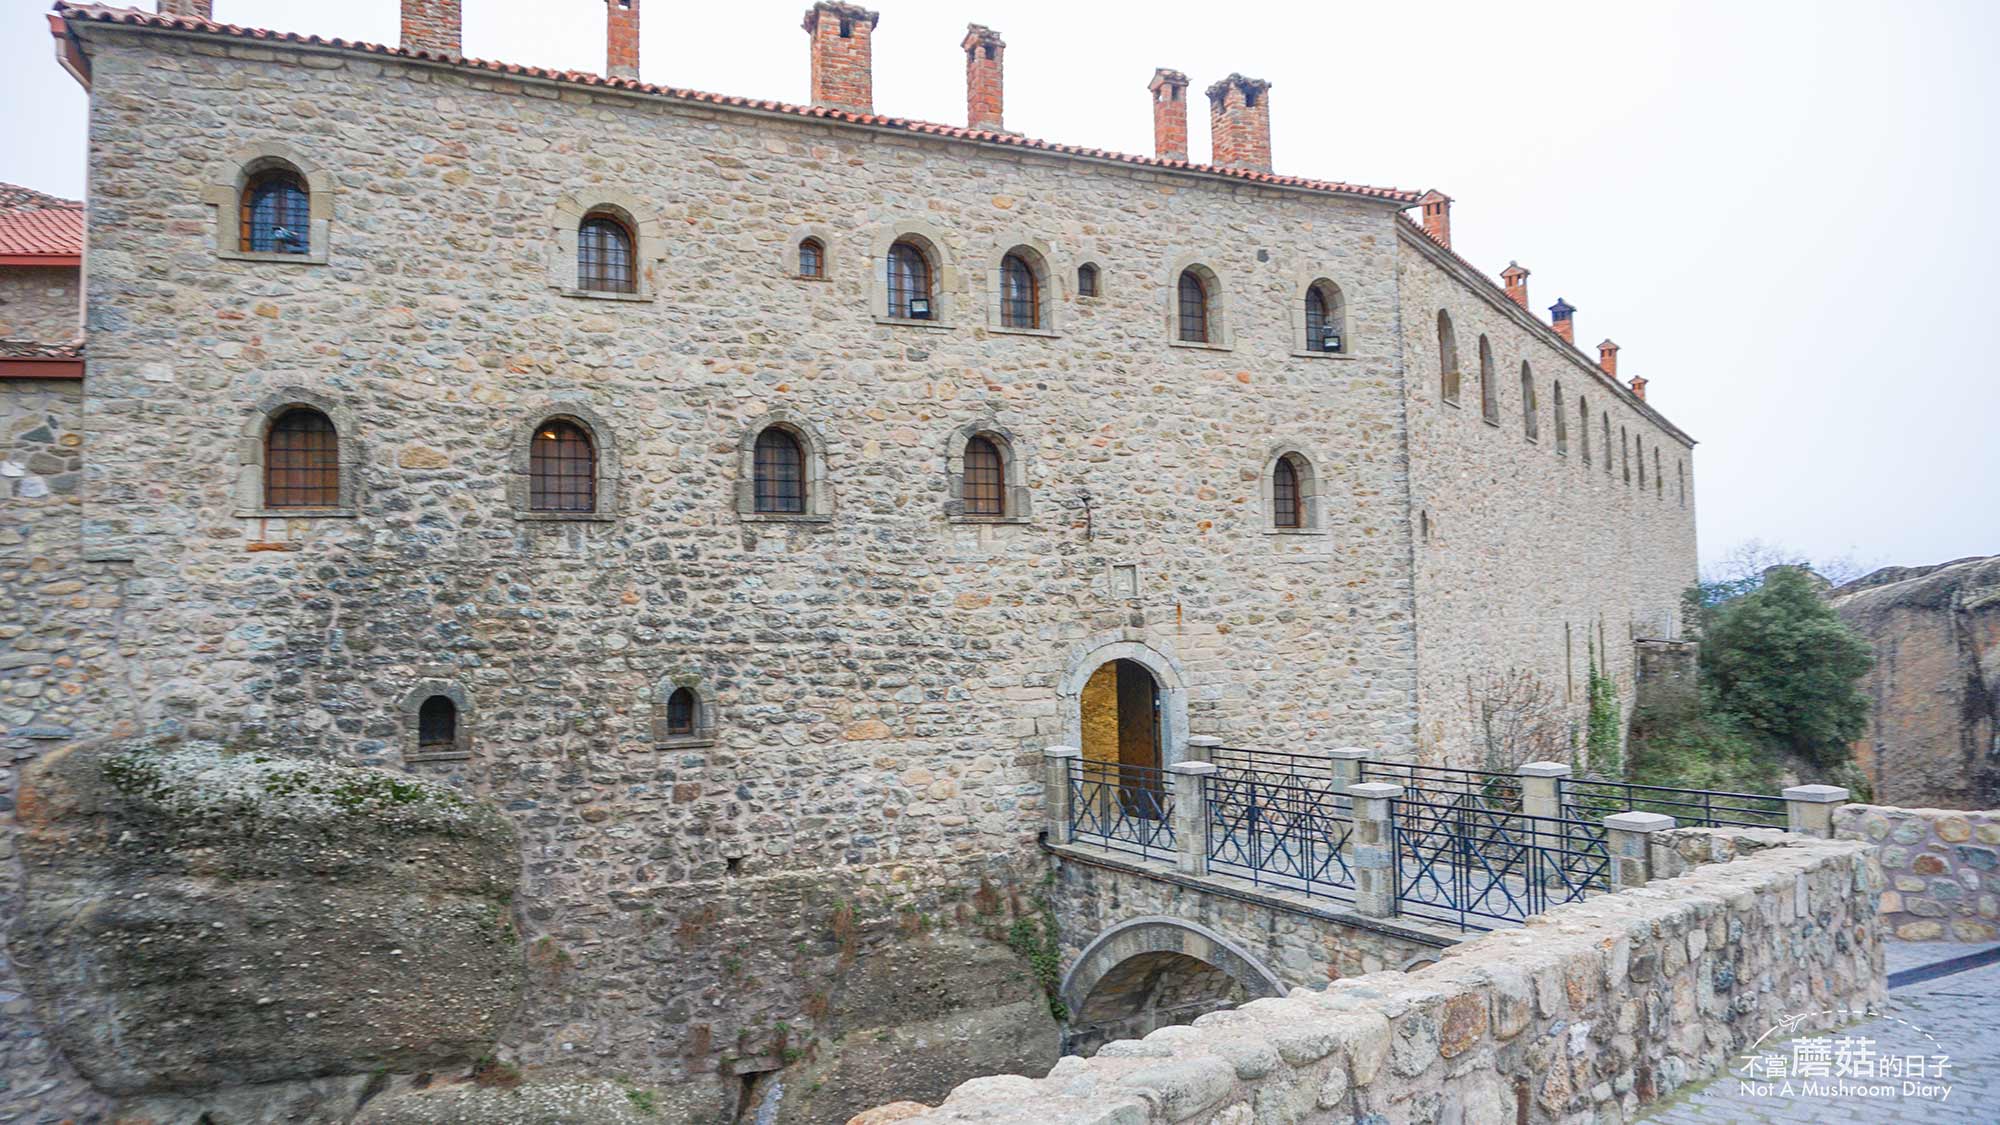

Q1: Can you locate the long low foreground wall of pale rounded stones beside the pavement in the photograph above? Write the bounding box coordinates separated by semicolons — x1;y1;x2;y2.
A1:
858;837;1884;1125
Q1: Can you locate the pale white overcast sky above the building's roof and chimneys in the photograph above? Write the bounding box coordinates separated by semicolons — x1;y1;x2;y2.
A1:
0;0;2000;567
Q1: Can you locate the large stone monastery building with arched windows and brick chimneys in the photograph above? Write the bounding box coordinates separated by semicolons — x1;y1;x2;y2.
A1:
0;0;1696;1104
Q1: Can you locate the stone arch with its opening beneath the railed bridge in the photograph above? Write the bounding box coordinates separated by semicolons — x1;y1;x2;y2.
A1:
1060;915;1286;1053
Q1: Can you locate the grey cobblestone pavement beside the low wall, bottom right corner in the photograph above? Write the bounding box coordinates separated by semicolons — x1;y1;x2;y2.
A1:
1640;943;2000;1125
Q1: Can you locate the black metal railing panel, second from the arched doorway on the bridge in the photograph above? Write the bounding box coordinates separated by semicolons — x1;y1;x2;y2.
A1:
1202;765;1354;901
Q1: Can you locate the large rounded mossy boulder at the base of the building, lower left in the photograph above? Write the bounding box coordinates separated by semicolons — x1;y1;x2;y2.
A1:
10;743;522;1096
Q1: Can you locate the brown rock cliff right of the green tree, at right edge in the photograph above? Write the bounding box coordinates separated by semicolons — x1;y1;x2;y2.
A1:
1830;554;2000;809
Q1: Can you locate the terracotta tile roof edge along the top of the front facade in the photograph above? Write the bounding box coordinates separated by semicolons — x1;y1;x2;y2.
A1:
56;2;1416;206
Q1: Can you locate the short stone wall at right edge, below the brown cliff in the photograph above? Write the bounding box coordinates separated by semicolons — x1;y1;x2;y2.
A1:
1834;805;2000;941
